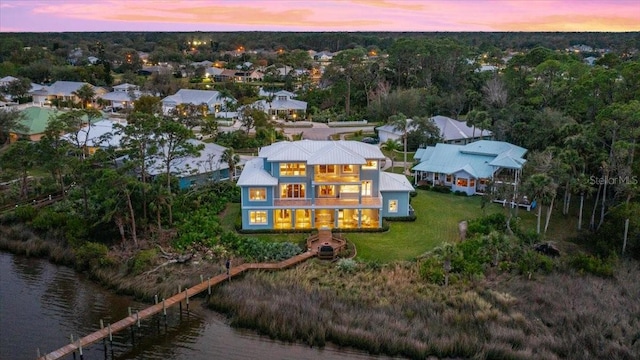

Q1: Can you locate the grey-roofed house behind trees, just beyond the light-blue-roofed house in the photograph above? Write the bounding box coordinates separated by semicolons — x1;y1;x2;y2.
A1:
376;115;493;144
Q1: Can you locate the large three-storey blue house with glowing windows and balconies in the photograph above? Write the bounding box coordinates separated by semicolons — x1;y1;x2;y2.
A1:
238;140;413;230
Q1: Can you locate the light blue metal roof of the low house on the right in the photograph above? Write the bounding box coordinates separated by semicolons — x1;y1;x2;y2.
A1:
413;140;527;178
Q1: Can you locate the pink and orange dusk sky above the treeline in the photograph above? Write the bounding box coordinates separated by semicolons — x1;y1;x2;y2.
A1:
0;0;640;32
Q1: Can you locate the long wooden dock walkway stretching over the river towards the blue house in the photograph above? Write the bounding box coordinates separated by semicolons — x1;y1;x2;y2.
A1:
38;250;317;360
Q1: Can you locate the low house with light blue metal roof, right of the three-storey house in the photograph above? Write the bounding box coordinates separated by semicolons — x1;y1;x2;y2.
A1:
412;140;527;195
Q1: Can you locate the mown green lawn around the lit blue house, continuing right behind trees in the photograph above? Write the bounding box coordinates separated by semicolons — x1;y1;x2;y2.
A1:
221;190;590;262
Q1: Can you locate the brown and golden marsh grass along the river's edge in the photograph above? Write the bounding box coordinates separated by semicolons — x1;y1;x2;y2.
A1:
209;260;640;359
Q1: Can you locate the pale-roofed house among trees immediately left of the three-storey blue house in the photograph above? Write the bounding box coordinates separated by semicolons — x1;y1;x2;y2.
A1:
148;140;245;189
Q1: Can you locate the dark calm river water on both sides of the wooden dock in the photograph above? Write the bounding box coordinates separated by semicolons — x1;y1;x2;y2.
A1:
0;252;400;360
